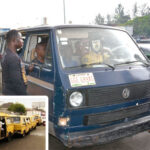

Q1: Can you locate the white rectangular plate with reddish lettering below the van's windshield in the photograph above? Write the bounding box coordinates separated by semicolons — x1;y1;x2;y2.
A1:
69;73;96;87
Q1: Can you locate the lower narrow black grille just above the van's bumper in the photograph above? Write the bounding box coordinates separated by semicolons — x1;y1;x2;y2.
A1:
83;102;150;125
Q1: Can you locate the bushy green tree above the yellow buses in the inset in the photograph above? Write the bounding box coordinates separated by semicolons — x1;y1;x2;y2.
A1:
8;103;26;114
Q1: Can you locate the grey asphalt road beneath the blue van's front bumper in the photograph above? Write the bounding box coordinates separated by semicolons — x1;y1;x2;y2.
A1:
49;132;150;150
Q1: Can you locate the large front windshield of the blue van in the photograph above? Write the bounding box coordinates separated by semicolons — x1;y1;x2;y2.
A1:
56;28;146;68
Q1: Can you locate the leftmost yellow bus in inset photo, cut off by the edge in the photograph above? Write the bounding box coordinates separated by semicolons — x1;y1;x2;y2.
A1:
0;113;14;141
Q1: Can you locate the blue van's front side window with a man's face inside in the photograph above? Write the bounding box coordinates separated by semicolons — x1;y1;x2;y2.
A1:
24;33;50;66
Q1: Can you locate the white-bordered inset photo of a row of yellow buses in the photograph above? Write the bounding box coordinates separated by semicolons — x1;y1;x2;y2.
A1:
0;96;48;150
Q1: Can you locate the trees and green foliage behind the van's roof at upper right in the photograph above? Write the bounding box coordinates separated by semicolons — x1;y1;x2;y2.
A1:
94;3;150;37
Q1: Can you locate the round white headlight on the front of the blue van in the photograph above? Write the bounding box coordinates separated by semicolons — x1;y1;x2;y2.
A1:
69;92;83;107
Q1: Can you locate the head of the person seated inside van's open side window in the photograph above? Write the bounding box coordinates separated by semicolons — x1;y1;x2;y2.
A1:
35;43;46;59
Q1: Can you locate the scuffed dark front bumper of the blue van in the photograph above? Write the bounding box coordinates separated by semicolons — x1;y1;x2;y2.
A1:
61;116;150;147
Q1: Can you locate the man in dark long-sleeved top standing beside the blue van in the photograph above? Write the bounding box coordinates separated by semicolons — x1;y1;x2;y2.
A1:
2;30;27;95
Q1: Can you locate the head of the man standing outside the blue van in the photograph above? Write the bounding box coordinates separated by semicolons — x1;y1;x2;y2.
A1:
6;30;23;49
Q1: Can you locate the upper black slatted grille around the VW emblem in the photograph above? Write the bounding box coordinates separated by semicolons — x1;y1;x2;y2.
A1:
86;81;150;106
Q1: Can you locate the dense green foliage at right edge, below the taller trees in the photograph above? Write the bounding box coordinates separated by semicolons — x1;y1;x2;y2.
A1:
124;15;150;36
